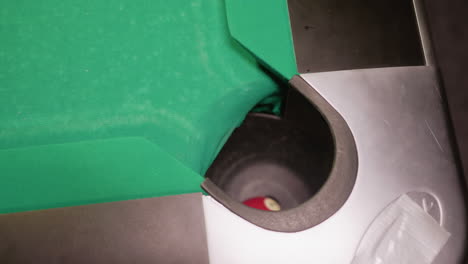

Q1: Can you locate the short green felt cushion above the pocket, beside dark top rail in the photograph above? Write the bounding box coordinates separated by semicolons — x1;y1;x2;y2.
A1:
226;0;297;80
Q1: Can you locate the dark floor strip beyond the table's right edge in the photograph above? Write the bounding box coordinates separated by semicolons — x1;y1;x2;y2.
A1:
426;0;468;263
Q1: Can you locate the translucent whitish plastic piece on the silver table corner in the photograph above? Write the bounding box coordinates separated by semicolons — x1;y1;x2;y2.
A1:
352;195;450;264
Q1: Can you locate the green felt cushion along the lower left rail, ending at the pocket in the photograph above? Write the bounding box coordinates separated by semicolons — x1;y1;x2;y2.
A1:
0;138;203;213
